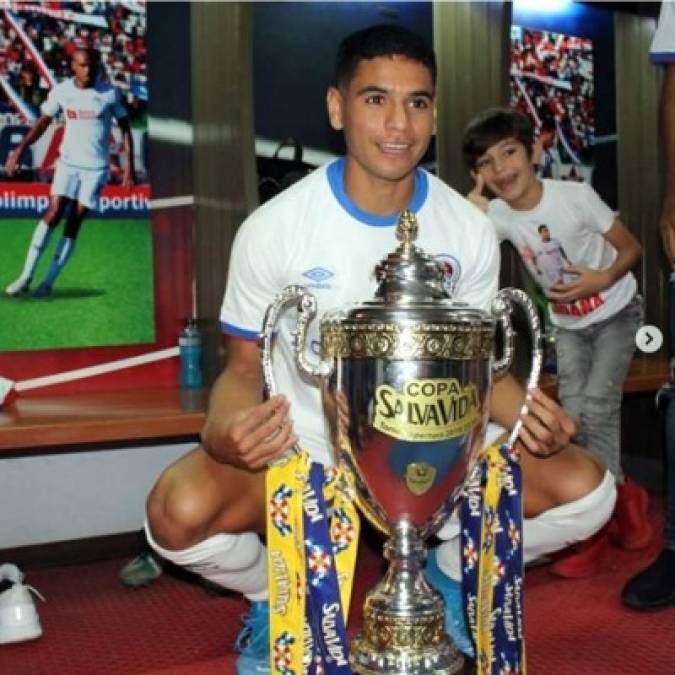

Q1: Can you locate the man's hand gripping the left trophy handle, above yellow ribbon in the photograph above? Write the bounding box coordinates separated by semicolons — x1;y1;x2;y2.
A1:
204;394;298;471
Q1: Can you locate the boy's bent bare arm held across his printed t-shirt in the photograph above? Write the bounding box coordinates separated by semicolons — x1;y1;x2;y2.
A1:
549;218;642;302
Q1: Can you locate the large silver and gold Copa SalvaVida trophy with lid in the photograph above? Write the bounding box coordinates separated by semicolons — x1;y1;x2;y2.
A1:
262;211;542;675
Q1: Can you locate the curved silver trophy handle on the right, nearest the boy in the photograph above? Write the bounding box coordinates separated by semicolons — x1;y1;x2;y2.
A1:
492;288;543;446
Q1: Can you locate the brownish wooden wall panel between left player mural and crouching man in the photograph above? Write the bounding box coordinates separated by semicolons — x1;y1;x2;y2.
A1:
191;2;257;381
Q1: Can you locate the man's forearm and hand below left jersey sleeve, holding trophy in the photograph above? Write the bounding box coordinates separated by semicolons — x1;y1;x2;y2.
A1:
201;339;297;471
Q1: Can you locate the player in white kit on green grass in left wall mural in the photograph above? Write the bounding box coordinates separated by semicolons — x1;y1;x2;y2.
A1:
5;48;135;298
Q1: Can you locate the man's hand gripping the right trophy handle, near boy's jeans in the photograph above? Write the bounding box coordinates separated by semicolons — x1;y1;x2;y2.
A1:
517;389;577;458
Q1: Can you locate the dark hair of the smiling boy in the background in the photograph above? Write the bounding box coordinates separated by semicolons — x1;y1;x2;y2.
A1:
462;108;534;169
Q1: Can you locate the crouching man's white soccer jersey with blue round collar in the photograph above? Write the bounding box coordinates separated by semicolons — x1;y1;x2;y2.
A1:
221;159;499;464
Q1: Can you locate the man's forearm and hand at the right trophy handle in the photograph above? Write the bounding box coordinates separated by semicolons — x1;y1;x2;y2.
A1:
490;373;577;458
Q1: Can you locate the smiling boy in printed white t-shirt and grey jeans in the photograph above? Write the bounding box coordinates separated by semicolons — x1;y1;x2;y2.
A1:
463;108;652;568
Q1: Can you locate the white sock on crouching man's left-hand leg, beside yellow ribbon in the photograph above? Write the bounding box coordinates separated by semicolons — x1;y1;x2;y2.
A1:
145;522;267;602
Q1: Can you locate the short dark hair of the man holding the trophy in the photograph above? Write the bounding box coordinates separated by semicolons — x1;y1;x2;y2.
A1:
333;24;436;87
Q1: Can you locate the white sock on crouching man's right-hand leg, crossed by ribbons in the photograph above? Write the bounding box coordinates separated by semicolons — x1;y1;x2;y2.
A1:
436;471;616;581
